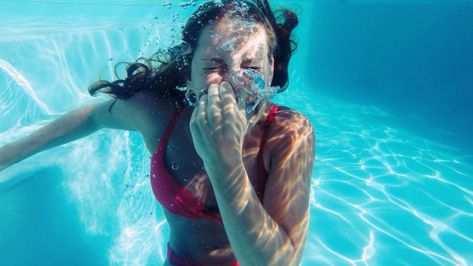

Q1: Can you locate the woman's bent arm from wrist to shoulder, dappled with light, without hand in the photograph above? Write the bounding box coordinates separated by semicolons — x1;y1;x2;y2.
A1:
205;110;315;266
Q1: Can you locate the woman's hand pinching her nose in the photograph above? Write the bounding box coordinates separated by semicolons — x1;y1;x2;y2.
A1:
190;82;247;167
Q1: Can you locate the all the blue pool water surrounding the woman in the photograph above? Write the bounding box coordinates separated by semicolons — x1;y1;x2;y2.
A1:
0;0;473;266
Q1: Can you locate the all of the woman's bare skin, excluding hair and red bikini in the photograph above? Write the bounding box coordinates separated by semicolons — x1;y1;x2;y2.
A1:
0;8;315;265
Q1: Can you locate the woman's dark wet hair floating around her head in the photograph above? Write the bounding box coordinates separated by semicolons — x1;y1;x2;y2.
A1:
88;0;299;111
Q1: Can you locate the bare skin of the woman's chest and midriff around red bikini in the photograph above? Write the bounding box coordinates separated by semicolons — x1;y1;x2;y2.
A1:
136;93;271;264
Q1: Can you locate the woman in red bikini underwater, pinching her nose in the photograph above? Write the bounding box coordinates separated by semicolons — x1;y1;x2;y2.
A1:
0;0;315;266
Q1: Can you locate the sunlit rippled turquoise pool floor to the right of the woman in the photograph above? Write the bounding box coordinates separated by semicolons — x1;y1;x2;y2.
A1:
272;86;473;265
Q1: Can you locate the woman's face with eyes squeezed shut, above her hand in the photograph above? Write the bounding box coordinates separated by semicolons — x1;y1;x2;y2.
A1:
188;16;274;101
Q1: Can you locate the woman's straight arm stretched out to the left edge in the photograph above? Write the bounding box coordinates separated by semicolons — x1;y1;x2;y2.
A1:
0;93;149;171
